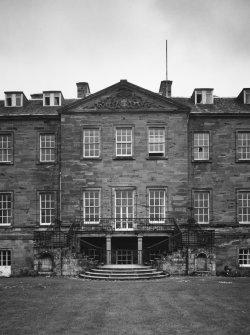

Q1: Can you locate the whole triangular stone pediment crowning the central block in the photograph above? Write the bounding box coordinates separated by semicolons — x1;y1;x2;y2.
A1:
61;80;187;112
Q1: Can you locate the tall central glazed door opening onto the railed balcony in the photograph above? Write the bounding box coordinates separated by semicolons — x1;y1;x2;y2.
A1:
114;188;135;231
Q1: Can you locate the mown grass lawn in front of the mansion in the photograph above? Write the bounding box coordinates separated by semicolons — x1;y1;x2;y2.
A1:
0;277;250;335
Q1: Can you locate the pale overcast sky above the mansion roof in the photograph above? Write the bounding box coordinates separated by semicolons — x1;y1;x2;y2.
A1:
0;0;250;99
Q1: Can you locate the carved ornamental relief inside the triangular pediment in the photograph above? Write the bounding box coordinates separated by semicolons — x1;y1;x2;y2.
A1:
85;89;161;109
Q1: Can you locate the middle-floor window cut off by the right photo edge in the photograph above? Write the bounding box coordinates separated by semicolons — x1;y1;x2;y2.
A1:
237;190;250;225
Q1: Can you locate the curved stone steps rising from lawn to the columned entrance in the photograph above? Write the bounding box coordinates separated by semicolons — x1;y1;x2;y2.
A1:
79;265;169;280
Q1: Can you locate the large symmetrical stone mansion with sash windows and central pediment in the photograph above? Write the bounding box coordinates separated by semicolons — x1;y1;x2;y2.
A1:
0;80;250;275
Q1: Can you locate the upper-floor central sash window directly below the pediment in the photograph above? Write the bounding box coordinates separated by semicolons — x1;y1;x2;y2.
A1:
115;126;133;157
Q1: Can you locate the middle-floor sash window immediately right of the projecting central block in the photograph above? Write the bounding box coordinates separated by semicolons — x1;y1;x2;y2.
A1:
193;190;210;224
